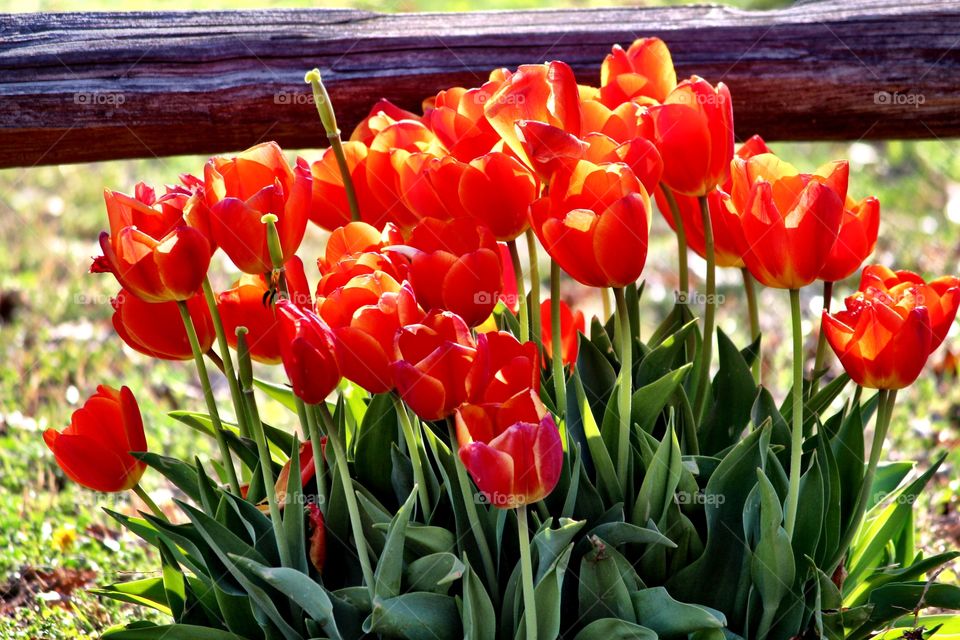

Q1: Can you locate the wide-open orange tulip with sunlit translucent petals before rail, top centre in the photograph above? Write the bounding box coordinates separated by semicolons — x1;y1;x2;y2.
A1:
483;61;580;167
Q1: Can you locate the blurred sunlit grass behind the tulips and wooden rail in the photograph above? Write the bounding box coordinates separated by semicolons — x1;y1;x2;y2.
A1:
0;0;960;639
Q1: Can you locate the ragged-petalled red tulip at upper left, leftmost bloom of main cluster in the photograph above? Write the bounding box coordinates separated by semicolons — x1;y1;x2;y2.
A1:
90;183;212;302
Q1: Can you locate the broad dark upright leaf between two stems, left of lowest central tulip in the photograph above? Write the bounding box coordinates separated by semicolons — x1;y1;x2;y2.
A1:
353;393;399;495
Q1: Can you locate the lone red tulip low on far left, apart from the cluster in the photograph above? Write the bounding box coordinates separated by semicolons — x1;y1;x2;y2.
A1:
43;385;147;492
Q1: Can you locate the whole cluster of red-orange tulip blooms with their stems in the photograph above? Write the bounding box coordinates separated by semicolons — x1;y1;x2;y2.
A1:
44;38;960;638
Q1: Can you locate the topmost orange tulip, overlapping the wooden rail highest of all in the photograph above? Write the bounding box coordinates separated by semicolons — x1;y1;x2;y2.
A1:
600;38;677;109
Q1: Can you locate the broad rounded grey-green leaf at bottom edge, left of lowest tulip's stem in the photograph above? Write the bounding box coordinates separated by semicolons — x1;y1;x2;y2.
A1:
363;592;462;640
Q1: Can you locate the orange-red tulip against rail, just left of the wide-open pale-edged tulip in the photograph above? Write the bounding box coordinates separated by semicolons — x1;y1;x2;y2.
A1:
423;70;509;162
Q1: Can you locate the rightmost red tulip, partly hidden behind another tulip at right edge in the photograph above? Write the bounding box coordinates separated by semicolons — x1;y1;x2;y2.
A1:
848;264;960;351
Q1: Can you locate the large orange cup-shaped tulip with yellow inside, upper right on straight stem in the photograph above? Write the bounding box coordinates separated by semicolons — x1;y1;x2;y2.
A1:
730;153;849;289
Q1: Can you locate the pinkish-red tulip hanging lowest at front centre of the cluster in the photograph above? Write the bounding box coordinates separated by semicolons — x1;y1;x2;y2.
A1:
457;405;563;509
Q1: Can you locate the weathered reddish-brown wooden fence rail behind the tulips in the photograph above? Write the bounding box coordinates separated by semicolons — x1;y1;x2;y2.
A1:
0;0;960;166
